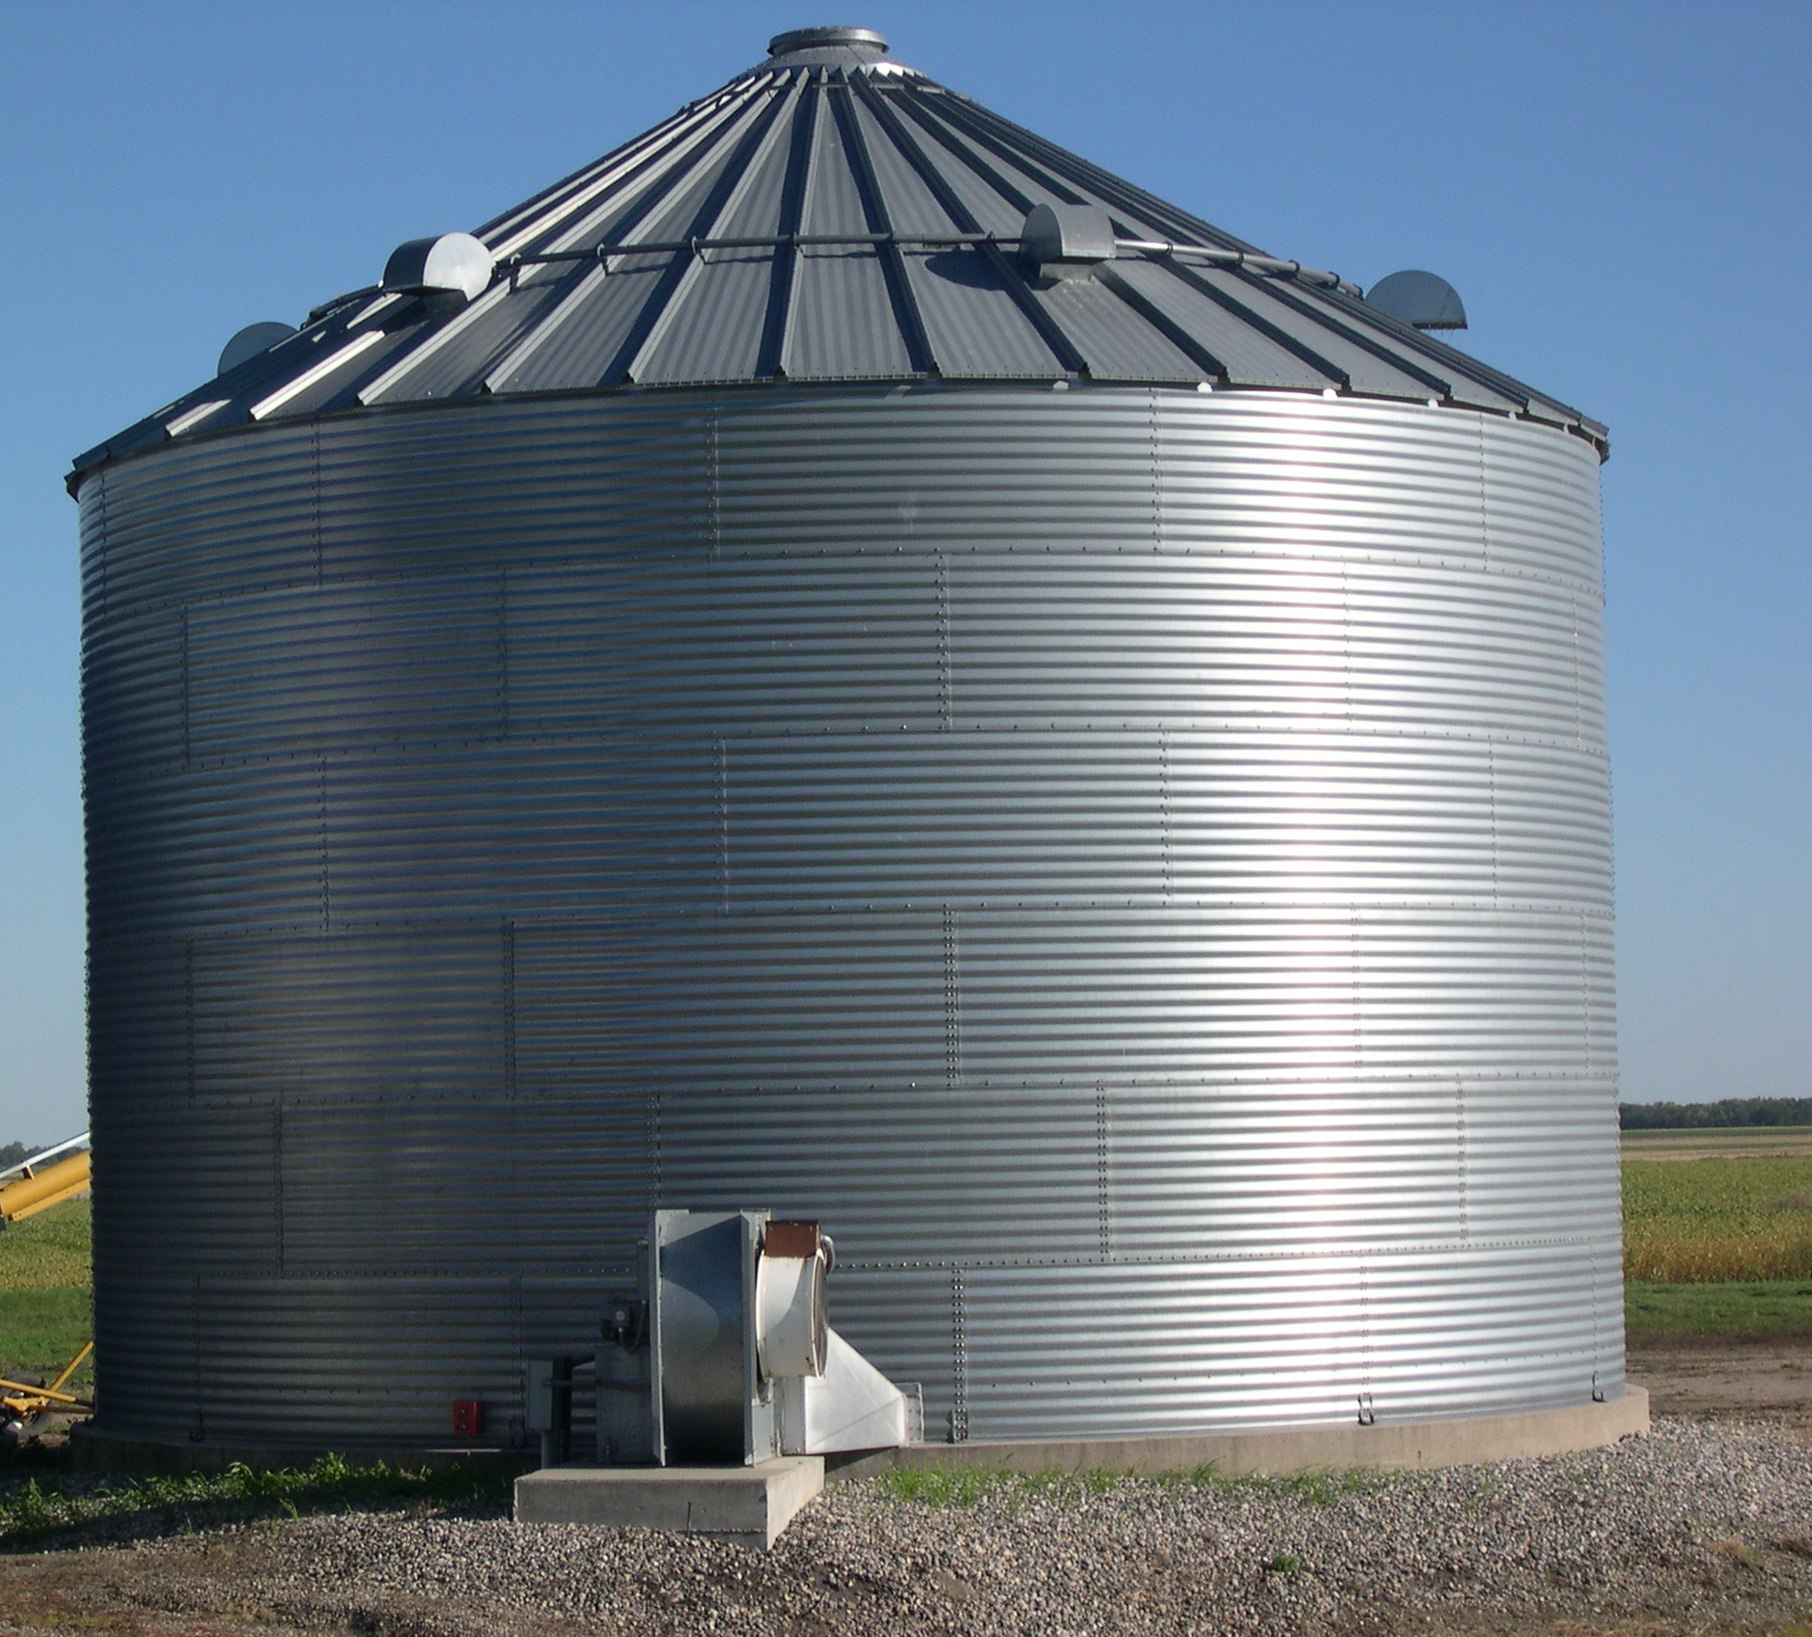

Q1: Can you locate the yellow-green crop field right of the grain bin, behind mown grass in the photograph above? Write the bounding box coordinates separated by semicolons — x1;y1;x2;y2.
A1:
1624;1155;1812;1285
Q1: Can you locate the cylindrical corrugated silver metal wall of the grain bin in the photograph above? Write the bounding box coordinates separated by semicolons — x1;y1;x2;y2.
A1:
82;388;1622;1447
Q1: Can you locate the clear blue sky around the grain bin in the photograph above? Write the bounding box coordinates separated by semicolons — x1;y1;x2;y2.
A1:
0;0;1812;1142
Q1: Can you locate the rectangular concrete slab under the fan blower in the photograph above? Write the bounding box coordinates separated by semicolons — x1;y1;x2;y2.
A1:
516;1456;824;1552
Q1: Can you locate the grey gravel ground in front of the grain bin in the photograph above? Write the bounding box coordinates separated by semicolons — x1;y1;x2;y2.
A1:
0;1421;1812;1637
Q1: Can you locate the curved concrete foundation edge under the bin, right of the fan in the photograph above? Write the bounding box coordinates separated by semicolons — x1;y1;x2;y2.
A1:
832;1385;1649;1479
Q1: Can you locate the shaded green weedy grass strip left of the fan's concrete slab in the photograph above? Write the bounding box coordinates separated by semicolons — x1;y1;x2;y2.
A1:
0;1456;513;1548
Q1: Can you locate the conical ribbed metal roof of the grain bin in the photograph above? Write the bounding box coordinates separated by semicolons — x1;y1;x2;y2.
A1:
71;27;1605;488
